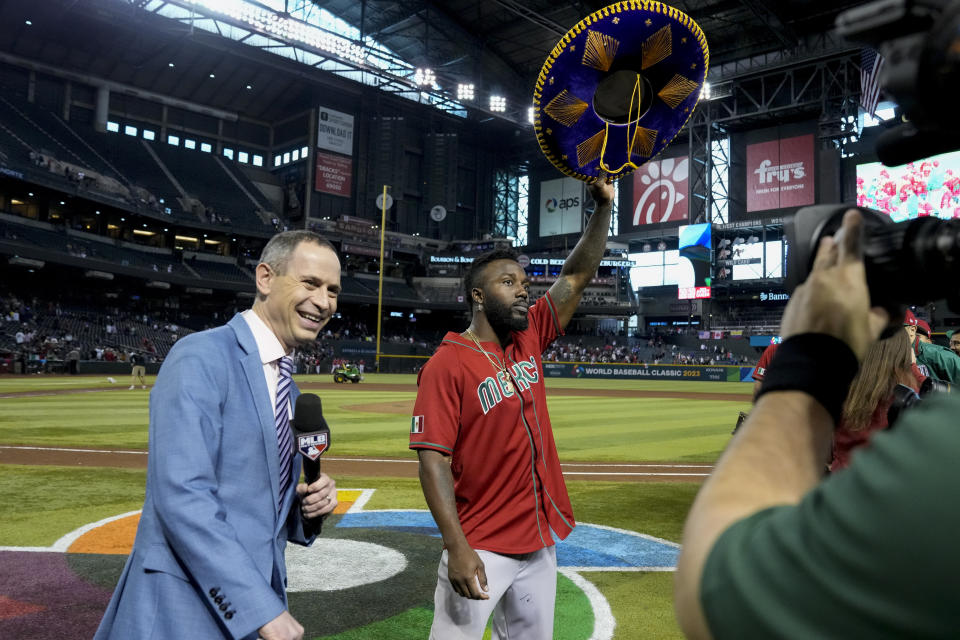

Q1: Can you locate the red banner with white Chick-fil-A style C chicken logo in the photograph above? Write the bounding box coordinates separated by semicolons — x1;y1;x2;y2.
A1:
633;158;690;227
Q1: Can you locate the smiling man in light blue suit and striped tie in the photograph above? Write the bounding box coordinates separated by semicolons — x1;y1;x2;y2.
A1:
95;231;340;640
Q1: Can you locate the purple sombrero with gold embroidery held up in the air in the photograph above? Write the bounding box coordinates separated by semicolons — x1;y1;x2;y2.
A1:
533;2;710;183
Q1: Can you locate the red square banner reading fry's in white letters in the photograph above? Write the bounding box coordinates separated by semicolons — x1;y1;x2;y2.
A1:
747;134;815;212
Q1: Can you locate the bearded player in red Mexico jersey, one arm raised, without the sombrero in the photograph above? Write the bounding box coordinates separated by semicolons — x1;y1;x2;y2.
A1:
410;184;613;640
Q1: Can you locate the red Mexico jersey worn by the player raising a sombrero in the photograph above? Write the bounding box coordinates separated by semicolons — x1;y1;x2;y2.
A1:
410;294;575;553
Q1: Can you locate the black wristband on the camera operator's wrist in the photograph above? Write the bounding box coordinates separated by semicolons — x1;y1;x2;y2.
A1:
757;333;860;424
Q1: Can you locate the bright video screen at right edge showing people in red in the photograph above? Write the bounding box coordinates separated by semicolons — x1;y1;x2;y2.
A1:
857;151;960;222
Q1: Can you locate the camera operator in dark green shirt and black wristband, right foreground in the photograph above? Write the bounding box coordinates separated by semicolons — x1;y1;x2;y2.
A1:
675;211;960;640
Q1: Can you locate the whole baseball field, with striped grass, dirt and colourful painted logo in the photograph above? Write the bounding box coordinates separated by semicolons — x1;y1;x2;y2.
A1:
0;375;751;640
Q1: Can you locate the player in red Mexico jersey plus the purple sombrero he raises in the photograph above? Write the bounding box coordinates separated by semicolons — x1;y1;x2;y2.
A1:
410;2;706;640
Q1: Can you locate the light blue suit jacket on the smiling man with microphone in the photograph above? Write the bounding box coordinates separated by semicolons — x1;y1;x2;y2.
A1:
95;315;313;640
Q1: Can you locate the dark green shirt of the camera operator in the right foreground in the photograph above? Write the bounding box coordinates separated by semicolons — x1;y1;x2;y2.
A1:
700;396;960;640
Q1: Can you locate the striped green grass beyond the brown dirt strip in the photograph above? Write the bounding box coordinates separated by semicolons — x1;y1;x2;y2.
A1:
0;375;750;462
